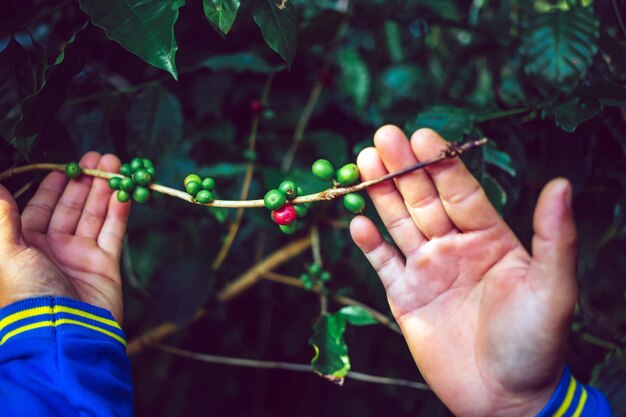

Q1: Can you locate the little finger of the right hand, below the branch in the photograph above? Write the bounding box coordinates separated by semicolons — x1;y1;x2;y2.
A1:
350;216;404;289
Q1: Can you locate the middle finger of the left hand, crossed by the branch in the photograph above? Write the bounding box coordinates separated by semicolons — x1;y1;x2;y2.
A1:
48;152;100;234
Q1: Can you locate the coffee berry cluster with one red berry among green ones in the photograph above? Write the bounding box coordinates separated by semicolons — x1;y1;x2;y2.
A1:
263;181;310;235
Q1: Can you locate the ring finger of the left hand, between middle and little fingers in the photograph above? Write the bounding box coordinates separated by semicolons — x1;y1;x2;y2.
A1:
76;154;121;240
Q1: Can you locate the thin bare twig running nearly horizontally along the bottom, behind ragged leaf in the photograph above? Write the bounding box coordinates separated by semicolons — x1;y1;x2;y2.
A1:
153;343;430;391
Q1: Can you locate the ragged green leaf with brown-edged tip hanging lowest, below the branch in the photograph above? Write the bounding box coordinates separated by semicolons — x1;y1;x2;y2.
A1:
309;314;350;383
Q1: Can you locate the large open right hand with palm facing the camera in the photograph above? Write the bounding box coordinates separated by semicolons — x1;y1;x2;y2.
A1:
350;126;577;417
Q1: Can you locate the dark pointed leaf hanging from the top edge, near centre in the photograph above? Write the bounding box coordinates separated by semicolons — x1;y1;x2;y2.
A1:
252;0;298;68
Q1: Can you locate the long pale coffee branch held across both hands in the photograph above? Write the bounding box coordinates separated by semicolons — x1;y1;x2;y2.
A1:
0;138;487;208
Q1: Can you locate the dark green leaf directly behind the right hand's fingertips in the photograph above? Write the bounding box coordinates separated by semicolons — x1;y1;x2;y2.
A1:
404;106;474;142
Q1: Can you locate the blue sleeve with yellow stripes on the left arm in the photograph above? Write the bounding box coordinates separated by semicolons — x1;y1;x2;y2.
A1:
0;297;133;417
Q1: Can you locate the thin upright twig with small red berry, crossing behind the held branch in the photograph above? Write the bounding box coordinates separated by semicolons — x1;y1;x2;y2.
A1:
211;73;274;271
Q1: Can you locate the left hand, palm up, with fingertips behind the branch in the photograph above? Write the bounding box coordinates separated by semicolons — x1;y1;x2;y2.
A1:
0;152;130;324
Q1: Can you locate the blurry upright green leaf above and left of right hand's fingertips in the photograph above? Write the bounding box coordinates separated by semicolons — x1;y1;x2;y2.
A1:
337;48;372;110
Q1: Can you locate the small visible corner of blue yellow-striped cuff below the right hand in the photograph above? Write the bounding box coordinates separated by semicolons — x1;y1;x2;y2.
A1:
537;367;613;417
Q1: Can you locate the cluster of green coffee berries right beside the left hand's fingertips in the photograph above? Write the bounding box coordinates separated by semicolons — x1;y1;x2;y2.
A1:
109;158;155;203
